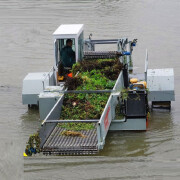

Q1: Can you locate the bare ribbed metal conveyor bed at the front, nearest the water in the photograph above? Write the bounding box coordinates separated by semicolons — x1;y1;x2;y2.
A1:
42;123;98;155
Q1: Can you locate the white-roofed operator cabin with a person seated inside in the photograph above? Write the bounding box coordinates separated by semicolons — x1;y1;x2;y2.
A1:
53;24;84;80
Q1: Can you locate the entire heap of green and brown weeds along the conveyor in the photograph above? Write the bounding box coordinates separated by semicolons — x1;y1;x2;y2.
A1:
59;59;122;131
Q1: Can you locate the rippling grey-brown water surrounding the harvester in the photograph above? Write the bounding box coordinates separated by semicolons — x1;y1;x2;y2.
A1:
0;0;180;180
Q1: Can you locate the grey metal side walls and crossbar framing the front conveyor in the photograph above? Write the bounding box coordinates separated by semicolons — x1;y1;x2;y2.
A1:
40;72;123;154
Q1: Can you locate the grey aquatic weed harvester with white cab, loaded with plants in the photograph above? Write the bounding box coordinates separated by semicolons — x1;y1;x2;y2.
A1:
22;24;175;155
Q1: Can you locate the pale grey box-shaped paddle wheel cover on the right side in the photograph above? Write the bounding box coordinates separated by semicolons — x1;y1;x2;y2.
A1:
147;68;174;91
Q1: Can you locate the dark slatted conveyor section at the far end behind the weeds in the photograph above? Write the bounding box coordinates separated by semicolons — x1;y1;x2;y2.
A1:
84;51;121;59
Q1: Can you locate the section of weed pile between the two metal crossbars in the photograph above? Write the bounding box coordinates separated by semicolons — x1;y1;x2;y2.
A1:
61;93;109;120
